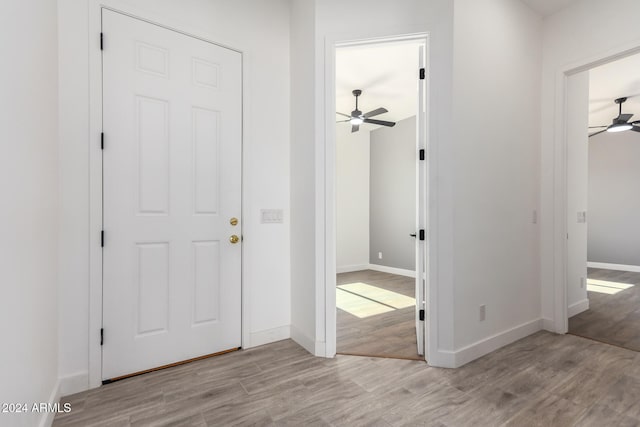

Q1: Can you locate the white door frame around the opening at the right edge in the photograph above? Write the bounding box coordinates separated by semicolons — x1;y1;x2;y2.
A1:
553;41;640;334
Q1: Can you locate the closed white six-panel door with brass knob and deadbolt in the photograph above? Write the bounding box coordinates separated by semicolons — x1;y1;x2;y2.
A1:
102;9;242;379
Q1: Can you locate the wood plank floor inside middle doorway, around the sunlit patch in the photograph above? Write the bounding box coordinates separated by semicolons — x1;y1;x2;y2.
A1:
336;270;423;360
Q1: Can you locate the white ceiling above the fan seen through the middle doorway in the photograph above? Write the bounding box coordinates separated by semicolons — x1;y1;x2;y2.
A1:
336;42;419;130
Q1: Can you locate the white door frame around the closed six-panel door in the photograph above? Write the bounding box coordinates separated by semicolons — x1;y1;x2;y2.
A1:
87;0;250;388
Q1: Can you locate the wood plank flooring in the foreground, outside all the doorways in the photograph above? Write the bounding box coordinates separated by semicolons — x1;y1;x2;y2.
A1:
54;332;640;427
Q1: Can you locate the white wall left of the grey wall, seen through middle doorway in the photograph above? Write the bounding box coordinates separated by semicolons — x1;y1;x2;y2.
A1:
336;123;371;273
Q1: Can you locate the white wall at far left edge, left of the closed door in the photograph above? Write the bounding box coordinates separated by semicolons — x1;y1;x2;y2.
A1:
0;0;58;426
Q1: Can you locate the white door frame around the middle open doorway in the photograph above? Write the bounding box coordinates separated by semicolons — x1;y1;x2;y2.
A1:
316;32;437;360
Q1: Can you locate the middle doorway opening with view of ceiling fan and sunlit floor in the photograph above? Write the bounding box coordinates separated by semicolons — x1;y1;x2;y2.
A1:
335;38;427;360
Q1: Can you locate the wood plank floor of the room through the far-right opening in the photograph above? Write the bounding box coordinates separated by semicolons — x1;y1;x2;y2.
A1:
569;268;640;351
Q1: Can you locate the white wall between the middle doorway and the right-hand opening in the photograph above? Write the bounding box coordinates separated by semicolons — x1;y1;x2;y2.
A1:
453;0;541;354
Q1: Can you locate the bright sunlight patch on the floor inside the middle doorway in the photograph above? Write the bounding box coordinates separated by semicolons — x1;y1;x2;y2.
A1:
336;282;416;319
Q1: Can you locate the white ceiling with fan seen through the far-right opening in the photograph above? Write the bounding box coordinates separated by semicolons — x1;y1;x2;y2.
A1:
589;54;640;126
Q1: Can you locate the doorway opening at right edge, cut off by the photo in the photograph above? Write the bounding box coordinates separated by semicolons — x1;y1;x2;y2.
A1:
567;53;640;351
